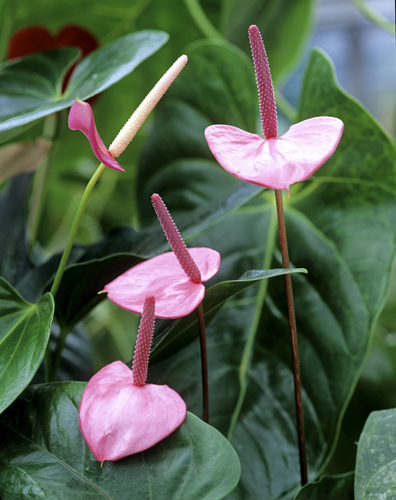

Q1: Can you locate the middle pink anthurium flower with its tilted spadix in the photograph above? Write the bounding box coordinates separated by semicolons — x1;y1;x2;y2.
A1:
104;194;220;318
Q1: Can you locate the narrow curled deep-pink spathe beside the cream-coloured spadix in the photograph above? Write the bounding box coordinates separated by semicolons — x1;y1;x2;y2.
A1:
69;99;125;172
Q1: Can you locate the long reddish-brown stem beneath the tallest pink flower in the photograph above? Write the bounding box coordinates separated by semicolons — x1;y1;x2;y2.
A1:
275;189;308;486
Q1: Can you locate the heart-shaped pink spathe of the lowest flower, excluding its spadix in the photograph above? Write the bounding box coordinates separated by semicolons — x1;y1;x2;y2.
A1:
79;361;187;462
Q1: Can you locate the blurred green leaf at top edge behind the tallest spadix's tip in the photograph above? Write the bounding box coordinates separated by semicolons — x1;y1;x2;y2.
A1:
221;0;314;82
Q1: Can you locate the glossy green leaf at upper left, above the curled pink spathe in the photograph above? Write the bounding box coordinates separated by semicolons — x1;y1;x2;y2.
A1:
0;30;168;140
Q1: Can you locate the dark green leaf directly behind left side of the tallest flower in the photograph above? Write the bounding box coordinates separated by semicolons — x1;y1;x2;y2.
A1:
137;41;258;225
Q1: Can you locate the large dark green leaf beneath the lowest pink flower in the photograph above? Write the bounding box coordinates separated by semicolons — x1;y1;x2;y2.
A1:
0;382;240;500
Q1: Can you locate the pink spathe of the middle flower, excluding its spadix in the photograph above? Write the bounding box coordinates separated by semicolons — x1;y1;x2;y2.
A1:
104;248;221;318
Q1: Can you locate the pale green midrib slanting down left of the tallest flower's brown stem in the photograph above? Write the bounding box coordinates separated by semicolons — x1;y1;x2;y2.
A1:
227;205;276;441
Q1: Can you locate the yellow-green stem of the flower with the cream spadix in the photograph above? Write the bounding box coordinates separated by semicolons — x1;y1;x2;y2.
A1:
44;163;106;382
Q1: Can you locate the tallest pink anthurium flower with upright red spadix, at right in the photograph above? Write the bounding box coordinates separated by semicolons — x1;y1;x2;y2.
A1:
205;26;344;191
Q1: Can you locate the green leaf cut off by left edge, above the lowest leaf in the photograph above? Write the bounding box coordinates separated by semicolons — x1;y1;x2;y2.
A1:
0;278;54;412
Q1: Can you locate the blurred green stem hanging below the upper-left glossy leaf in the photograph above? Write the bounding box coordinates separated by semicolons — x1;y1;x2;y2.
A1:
28;113;62;251
